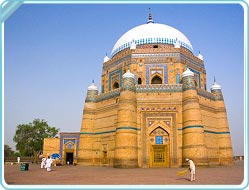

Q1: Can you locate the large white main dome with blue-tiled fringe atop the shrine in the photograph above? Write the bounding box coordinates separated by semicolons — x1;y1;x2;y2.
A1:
111;22;193;57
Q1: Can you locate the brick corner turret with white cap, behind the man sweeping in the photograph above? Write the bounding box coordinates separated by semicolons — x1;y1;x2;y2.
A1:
182;68;208;166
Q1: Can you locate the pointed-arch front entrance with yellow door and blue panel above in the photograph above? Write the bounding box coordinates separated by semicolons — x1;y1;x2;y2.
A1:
150;126;170;167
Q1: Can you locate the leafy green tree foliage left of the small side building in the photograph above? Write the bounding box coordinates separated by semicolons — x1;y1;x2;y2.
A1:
13;119;59;156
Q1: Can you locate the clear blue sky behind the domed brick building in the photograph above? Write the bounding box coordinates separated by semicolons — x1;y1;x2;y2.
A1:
3;3;245;155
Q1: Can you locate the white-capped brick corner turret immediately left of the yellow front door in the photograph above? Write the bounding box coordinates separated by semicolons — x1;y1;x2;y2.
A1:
114;70;138;168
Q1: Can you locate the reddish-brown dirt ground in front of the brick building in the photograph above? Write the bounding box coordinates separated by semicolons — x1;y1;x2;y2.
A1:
2;161;244;189
